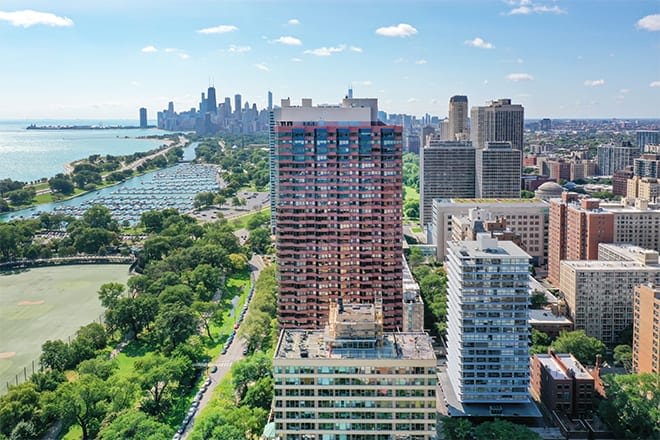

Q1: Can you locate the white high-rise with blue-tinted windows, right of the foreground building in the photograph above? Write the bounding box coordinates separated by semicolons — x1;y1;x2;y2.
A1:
445;234;530;405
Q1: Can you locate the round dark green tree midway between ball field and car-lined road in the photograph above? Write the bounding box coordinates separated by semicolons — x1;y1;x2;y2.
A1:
153;304;198;351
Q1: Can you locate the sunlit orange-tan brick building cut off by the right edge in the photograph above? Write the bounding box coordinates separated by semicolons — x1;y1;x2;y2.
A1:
633;284;660;374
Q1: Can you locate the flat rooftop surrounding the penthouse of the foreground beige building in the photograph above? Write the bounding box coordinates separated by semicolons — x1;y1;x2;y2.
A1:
275;329;435;360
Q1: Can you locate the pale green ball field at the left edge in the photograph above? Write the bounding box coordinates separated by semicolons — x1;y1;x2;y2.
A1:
0;264;128;394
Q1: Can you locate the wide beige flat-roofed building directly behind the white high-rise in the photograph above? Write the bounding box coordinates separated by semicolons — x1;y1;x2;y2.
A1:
431;199;549;267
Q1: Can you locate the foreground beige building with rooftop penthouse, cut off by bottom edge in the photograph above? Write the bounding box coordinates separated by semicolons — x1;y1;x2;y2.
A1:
273;301;437;440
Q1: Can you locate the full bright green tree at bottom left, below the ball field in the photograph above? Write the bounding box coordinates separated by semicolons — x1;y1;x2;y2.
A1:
55;375;109;440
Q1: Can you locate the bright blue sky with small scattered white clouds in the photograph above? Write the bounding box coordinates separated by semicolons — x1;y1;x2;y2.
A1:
0;0;660;119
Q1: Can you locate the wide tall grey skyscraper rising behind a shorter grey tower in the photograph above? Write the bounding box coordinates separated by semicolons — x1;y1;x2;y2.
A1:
470;99;525;151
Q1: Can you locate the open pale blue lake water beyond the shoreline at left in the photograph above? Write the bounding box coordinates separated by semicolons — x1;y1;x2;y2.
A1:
0;120;167;182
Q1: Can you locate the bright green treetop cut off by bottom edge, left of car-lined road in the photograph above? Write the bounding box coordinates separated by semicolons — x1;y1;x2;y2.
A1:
99;410;172;440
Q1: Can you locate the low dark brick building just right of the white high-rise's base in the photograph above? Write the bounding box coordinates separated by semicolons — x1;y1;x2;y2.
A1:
531;351;594;417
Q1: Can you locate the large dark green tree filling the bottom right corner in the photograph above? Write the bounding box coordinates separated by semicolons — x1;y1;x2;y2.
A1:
598;373;660;439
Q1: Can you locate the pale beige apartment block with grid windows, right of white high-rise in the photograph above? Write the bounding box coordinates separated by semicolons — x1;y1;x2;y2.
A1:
559;244;660;344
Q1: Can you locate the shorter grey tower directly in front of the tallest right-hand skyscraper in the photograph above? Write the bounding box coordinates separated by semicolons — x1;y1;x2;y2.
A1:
475;142;522;199
